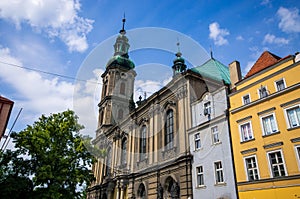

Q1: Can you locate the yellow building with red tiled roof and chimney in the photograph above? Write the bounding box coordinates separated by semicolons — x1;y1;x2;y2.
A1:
229;51;300;199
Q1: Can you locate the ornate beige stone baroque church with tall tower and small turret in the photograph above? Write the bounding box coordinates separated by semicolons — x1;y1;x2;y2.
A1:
87;20;233;199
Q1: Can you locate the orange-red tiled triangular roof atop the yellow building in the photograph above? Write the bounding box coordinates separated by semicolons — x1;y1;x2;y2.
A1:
245;51;281;78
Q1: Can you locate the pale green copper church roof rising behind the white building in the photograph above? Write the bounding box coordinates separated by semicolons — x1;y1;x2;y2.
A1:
190;58;230;84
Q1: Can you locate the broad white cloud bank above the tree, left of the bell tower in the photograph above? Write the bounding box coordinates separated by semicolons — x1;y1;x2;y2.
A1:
0;48;101;135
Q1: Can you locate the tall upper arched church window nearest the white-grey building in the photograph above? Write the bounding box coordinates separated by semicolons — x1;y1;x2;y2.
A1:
165;109;174;149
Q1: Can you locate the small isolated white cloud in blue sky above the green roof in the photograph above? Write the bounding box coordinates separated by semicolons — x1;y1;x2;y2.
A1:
209;22;229;46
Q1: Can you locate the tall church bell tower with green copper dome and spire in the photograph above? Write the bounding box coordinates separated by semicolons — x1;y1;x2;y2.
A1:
97;18;136;133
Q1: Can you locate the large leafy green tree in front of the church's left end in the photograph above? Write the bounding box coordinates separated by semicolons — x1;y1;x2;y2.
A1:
2;110;94;199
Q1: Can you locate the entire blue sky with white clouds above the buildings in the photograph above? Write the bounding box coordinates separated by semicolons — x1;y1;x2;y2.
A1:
0;0;300;145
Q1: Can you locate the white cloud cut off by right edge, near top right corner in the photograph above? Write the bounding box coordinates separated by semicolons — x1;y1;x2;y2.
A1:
277;7;300;33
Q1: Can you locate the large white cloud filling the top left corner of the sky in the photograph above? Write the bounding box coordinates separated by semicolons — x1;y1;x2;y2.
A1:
0;0;93;52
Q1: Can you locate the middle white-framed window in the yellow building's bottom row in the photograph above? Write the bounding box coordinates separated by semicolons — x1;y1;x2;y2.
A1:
268;151;286;178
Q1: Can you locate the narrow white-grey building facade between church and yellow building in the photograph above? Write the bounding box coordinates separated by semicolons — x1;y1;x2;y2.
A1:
188;59;237;199
